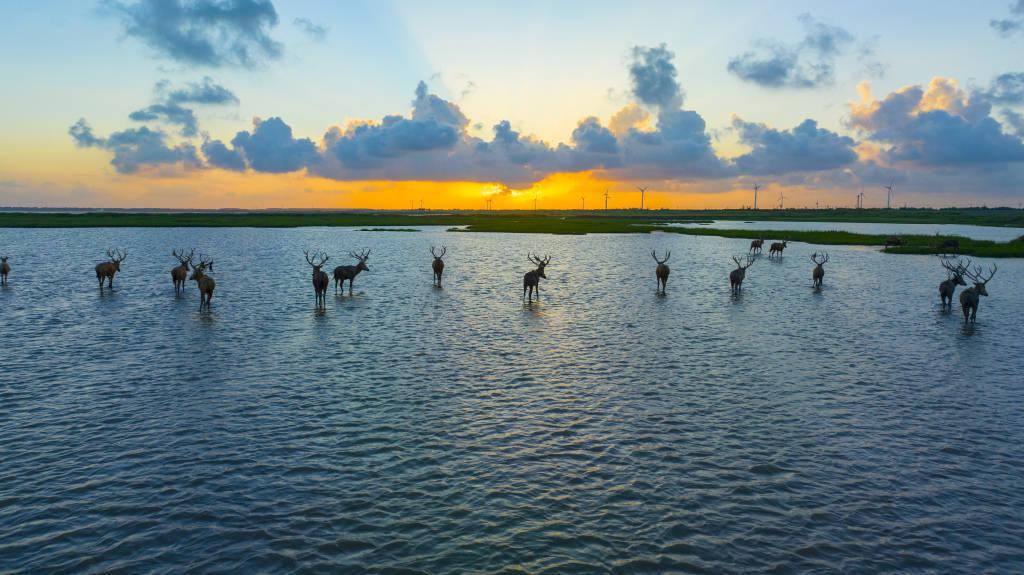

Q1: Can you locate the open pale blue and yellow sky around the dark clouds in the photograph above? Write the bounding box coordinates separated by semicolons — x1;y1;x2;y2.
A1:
0;0;1024;205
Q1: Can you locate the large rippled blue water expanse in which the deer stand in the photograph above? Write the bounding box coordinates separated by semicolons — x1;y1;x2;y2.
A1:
0;228;1024;573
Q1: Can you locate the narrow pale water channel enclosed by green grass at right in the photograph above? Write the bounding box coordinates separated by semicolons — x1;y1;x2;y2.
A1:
668;220;1024;241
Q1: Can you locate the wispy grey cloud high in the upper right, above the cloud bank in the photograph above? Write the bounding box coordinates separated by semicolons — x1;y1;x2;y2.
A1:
727;14;856;89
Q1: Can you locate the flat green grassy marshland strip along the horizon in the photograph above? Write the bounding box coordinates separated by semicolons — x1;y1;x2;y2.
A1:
6;208;1024;258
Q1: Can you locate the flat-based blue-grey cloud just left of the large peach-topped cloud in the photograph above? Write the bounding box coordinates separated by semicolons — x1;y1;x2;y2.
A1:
732;117;857;175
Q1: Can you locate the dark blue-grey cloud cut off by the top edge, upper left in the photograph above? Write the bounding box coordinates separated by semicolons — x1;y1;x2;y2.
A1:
103;0;283;68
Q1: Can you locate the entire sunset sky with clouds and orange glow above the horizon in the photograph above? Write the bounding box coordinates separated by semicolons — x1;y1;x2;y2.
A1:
0;0;1024;209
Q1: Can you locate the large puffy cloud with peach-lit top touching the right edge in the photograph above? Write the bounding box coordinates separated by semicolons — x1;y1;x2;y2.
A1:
849;78;1024;167
